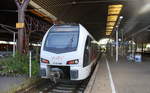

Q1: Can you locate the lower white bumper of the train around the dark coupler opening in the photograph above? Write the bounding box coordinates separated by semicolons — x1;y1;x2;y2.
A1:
40;62;91;80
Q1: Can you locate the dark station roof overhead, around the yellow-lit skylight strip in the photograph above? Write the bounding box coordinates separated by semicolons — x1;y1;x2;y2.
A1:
0;0;150;42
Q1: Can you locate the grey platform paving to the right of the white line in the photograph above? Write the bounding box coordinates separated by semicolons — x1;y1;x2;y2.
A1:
109;58;150;93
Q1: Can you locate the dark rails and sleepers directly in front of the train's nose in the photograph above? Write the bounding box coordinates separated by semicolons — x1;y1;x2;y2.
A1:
39;78;89;93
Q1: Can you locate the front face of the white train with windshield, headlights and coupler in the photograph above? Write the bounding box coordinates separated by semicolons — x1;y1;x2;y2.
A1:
40;25;83;80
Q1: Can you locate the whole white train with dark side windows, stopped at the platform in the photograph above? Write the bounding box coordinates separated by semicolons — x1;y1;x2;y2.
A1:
40;24;99;81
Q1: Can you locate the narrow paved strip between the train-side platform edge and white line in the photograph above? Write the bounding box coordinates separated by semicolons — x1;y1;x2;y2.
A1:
91;56;111;93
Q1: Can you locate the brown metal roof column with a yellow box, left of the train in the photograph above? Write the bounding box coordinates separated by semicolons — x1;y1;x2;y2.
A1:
15;0;30;54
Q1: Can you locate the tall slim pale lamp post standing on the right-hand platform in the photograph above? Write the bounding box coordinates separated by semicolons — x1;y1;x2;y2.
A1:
116;16;123;62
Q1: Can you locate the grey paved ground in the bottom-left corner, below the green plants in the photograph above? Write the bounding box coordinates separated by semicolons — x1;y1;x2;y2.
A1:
0;75;42;93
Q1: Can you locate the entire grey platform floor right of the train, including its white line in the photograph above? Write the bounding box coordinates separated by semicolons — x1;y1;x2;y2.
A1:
91;55;150;93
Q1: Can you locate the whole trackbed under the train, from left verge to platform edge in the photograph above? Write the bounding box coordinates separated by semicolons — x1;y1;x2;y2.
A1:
16;58;99;93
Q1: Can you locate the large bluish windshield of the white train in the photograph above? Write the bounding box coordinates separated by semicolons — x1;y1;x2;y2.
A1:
44;25;79;53
